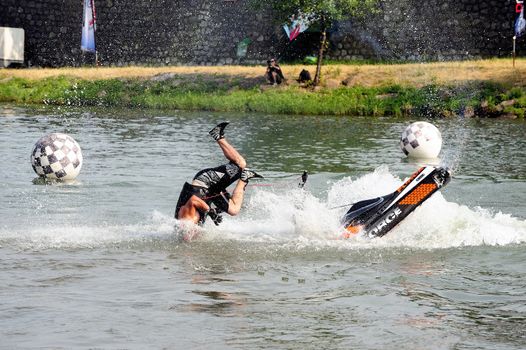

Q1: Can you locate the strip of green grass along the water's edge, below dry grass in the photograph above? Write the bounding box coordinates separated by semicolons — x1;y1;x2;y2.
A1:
0;75;526;118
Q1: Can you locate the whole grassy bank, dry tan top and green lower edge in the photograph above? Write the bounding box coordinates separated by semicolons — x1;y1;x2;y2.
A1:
0;60;526;118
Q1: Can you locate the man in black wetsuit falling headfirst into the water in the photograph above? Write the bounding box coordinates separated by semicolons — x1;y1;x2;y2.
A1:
175;122;262;225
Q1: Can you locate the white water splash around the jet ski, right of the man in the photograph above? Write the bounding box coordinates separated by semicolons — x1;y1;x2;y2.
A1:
211;167;526;249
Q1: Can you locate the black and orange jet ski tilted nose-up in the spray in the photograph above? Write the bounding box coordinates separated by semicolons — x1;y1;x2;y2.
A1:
341;166;451;238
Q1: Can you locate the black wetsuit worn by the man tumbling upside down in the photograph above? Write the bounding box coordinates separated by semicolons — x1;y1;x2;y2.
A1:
175;162;241;223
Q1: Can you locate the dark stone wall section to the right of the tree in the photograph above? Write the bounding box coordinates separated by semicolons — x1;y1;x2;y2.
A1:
329;0;526;61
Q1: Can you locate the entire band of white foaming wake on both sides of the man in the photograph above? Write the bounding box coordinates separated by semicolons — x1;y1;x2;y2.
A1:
0;166;526;249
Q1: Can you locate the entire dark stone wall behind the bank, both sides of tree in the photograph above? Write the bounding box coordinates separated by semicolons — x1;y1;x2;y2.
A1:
0;0;526;66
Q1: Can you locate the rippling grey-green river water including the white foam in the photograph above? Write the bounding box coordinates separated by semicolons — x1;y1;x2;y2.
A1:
0;105;526;349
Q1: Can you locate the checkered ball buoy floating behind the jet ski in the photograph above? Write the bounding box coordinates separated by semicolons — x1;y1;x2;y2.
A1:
400;122;442;159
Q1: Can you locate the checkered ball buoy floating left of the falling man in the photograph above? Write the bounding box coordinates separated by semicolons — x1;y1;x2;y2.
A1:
31;133;82;180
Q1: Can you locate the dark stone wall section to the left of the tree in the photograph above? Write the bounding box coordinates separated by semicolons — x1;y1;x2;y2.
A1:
0;0;279;66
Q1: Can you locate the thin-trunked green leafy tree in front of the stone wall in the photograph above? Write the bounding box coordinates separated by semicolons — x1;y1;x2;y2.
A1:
256;0;378;85
